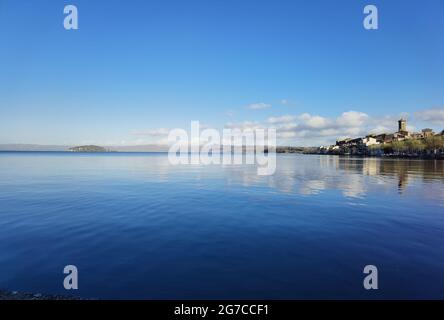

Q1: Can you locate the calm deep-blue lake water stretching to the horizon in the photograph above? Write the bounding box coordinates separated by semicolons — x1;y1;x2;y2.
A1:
0;153;444;299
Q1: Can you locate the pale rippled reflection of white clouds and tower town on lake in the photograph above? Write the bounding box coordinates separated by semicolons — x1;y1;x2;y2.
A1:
213;155;444;198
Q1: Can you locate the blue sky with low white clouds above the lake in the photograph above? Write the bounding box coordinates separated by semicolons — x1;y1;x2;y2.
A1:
0;0;444;145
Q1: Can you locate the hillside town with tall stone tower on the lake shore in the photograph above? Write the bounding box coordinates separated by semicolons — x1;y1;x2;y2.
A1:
319;119;444;158
